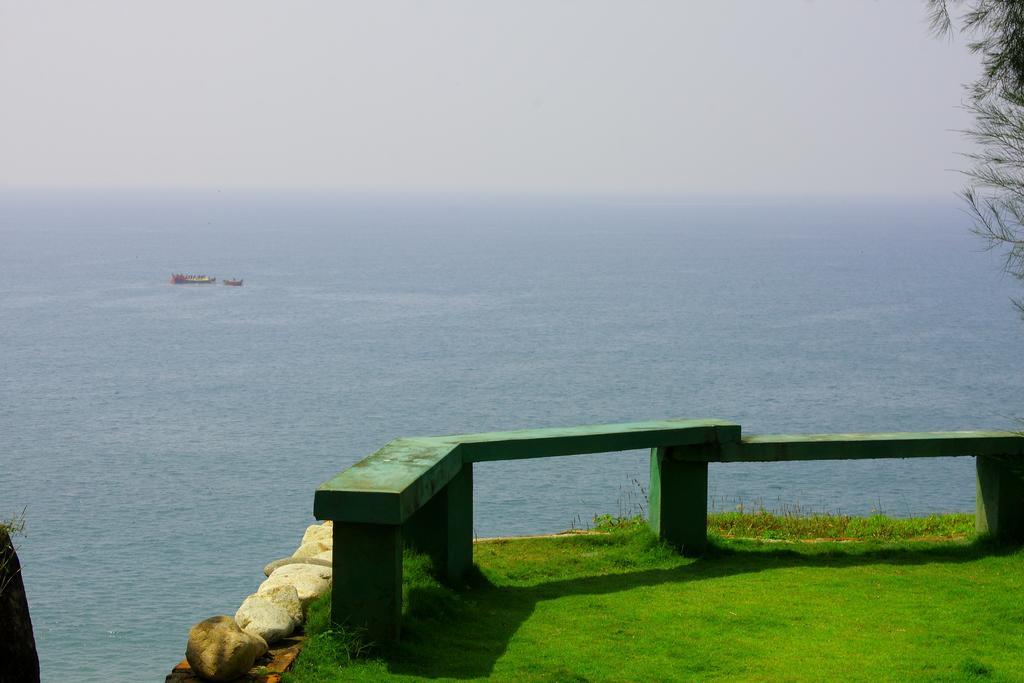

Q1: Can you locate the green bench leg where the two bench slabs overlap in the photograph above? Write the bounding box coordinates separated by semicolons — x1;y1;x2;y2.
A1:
648;449;708;557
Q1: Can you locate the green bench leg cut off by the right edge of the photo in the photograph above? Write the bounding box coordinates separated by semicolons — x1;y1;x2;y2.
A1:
975;456;1024;543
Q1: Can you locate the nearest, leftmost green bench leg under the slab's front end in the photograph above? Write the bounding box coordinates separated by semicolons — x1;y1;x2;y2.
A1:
331;521;401;641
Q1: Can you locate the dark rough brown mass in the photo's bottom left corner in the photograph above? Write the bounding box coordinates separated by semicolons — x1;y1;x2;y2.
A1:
0;525;39;683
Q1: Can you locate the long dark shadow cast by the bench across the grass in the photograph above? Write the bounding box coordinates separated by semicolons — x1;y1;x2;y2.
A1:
379;539;1019;679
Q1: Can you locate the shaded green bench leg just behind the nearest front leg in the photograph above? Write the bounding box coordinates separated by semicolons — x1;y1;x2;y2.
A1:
402;463;473;584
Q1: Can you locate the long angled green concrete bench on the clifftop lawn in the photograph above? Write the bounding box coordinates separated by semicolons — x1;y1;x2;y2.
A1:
313;420;1024;640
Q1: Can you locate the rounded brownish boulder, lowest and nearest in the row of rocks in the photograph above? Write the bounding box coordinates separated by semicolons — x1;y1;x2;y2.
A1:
185;616;266;681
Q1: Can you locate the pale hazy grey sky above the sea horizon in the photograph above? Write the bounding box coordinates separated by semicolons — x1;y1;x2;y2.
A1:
0;0;978;196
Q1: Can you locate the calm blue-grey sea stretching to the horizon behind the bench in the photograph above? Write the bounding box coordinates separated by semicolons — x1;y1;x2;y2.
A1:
0;193;1024;681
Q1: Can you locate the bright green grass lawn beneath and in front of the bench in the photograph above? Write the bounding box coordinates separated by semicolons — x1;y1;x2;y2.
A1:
286;513;1024;683
